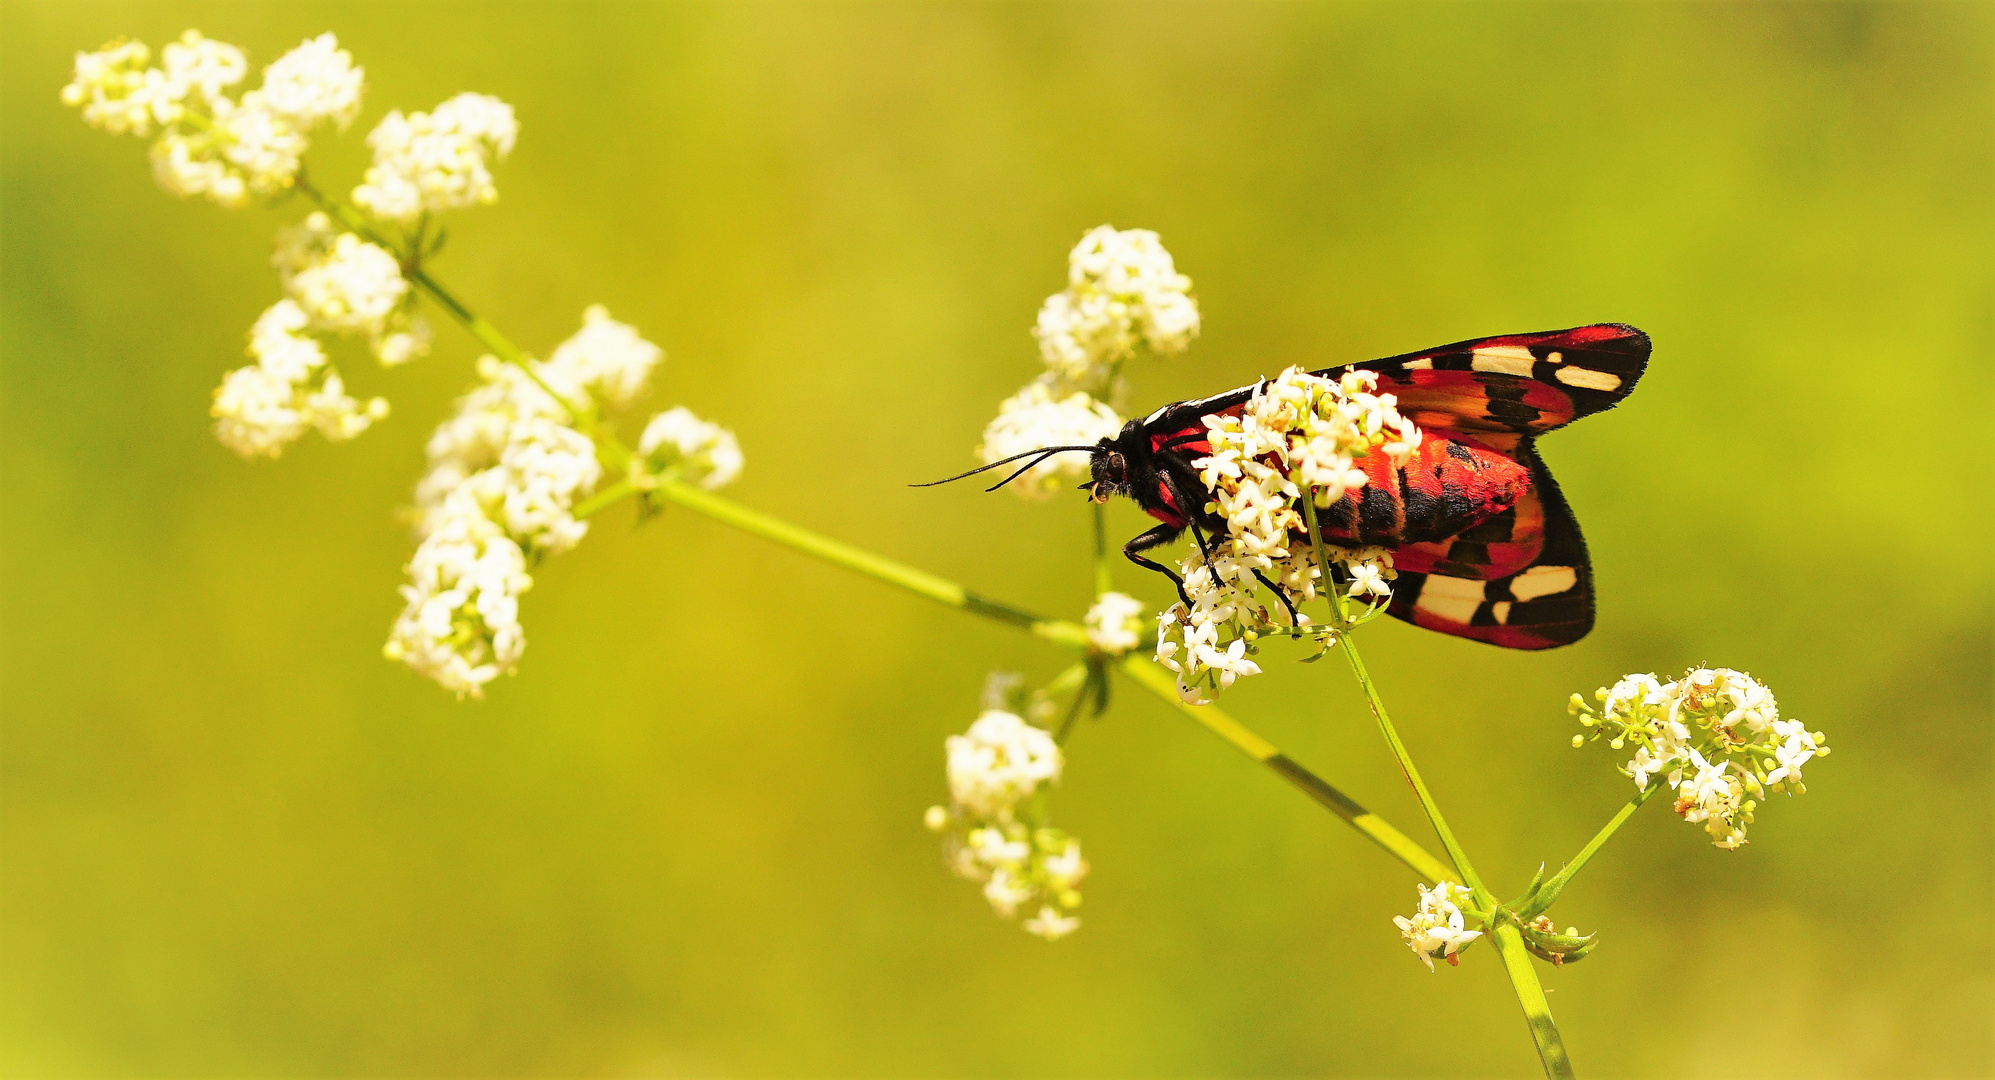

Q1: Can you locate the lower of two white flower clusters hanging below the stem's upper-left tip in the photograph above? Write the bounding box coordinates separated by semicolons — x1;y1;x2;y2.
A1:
209;299;387;459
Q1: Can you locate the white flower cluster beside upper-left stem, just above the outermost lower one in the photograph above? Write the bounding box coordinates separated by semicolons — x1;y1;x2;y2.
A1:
271;214;429;367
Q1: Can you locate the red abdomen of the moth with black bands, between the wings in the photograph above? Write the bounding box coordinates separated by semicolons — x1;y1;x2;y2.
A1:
1323;433;1530;547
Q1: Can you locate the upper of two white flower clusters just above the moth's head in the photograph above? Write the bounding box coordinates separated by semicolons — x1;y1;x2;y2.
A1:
1031;226;1199;393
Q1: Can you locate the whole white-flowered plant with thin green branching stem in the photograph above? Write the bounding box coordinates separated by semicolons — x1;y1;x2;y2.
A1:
62;32;1829;1076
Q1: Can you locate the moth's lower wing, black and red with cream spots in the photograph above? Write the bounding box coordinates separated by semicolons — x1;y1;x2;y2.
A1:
1387;443;1594;649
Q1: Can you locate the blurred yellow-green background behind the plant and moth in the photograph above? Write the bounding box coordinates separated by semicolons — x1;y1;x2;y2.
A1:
0;2;1995;1078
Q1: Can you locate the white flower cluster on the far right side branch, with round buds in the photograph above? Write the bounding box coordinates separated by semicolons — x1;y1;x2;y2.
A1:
1568;667;1829;850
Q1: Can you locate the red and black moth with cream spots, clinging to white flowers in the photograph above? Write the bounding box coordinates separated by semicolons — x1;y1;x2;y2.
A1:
918;323;1650;649
